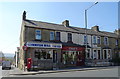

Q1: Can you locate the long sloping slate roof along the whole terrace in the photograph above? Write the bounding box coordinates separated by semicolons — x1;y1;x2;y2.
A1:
24;20;118;38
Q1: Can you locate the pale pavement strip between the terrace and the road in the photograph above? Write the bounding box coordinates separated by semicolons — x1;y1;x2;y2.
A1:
10;66;115;75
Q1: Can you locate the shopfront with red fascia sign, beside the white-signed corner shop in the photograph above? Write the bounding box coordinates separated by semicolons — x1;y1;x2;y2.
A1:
62;46;85;66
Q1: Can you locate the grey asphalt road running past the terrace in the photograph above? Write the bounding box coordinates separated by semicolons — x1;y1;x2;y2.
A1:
2;67;118;77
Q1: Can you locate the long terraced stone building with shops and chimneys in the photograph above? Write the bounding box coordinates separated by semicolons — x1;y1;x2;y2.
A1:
19;11;120;69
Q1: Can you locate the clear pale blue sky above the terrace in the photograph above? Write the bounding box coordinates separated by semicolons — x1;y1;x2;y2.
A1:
0;2;118;54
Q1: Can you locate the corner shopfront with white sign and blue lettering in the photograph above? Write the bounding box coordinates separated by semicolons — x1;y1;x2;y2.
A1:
25;42;62;69
